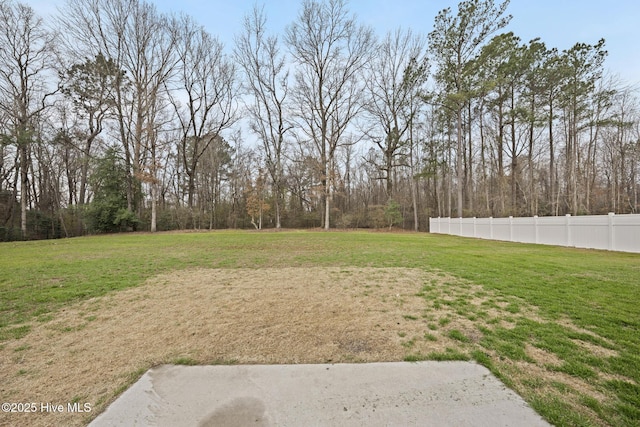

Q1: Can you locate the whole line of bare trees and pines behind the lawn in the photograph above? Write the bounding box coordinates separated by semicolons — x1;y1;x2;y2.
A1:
0;0;640;240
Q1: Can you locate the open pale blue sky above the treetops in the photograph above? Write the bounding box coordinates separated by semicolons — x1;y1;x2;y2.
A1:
32;0;640;84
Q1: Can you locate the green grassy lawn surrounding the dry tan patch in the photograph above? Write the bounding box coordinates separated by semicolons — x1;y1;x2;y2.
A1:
0;231;640;426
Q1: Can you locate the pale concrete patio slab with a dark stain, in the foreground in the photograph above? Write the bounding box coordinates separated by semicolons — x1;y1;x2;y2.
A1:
90;362;549;427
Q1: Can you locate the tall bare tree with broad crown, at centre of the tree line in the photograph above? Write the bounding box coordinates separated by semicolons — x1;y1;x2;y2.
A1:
286;0;374;230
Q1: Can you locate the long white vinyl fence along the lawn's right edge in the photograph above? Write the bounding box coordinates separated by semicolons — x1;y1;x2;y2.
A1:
429;213;640;253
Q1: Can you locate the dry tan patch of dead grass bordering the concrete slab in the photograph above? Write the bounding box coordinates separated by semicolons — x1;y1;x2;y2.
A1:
0;268;469;426
